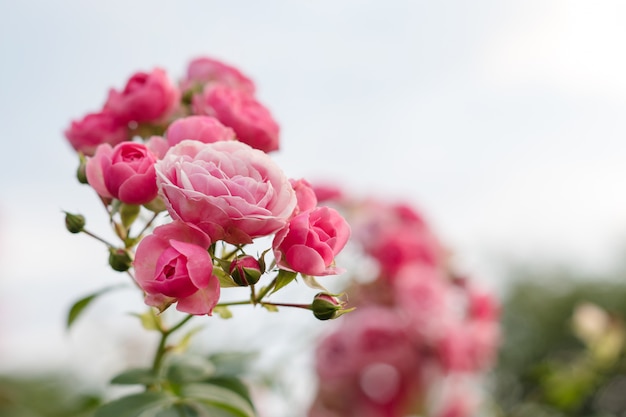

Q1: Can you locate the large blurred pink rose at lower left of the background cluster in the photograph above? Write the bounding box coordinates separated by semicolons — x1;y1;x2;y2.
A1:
309;306;422;417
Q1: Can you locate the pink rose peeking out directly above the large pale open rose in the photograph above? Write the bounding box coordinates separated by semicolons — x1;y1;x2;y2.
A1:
165;116;235;146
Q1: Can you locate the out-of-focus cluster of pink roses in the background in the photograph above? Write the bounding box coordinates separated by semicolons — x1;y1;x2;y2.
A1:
309;193;499;417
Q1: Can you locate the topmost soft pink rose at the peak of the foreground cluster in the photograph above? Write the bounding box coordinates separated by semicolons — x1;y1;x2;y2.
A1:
182;57;255;94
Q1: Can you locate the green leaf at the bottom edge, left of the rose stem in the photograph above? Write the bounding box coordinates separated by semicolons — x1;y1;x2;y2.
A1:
94;391;177;417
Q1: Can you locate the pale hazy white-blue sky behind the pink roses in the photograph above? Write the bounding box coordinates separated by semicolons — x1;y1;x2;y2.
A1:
0;0;626;410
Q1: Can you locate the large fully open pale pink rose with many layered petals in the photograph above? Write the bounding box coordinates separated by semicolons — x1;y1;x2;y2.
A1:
156;140;296;244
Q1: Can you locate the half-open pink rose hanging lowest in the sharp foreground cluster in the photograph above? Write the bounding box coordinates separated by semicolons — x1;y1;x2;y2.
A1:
133;221;220;315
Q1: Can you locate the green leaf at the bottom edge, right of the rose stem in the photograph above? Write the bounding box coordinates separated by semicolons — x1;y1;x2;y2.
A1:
182;384;256;417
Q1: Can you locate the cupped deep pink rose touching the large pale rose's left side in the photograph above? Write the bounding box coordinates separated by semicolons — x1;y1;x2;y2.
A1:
86;142;157;204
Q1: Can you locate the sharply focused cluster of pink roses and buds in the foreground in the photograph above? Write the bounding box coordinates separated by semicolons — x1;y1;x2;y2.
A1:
65;57;350;315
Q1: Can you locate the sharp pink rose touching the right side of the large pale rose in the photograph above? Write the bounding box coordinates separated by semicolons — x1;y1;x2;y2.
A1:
272;207;350;276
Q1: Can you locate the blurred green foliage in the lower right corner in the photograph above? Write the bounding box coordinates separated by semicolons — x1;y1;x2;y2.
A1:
494;264;626;417
